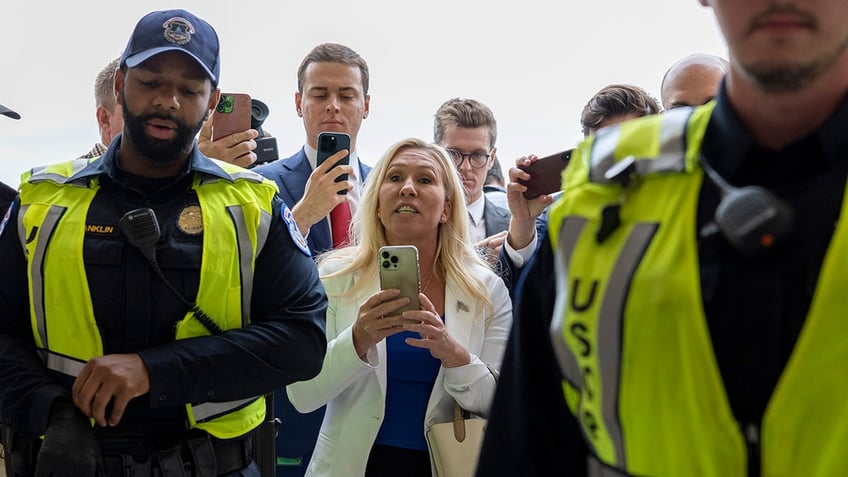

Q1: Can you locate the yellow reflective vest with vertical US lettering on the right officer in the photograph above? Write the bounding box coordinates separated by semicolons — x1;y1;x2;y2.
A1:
549;104;848;477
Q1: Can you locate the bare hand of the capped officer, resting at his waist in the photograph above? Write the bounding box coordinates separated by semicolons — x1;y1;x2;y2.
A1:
71;354;150;427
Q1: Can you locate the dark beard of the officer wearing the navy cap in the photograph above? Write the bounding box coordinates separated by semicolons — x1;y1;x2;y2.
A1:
121;96;205;164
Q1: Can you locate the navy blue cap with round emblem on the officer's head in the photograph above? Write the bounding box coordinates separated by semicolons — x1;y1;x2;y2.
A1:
121;10;221;87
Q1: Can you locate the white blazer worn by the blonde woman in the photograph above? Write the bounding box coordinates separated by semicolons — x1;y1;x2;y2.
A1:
282;267;512;477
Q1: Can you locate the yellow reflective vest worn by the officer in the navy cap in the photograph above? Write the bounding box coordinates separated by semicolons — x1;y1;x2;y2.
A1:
18;159;276;439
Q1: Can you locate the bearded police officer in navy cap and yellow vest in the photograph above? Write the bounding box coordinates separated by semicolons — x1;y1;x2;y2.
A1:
0;10;327;477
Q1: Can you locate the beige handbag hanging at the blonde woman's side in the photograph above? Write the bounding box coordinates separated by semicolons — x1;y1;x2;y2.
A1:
426;364;498;477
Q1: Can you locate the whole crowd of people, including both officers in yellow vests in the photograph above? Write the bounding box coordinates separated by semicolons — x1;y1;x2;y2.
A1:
6;0;848;477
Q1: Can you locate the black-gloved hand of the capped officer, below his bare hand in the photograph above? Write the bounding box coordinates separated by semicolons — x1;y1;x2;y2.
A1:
35;399;104;477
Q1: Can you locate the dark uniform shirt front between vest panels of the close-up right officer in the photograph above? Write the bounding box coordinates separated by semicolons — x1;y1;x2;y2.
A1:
699;82;848;427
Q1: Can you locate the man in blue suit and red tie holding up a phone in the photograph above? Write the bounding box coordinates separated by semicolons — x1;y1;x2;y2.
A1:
253;43;371;476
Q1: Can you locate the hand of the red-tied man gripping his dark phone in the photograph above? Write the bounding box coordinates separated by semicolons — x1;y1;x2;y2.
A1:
292;149;356;235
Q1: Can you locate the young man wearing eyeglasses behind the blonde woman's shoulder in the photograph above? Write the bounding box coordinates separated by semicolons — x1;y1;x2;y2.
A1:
433;98;510;262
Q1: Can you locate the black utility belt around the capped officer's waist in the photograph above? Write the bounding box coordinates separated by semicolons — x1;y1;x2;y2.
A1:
103;432;253;477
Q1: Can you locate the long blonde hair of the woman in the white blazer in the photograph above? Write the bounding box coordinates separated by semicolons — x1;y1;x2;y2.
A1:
317;138;492;310
